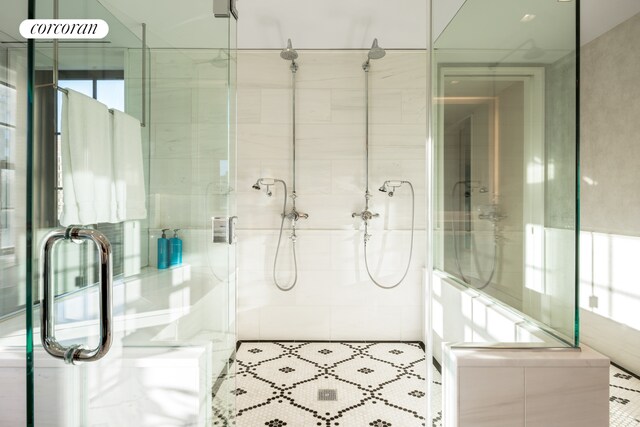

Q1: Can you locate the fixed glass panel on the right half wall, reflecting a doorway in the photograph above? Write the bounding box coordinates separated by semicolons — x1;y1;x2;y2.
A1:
432;0;578;346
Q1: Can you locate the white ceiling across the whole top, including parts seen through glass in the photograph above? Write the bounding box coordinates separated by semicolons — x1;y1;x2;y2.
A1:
0;0;640;49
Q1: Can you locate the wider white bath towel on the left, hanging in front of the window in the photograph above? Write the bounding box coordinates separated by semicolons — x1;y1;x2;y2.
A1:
60;89;117;226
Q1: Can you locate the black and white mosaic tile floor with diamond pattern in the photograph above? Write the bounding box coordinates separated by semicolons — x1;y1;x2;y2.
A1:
212;342;640;427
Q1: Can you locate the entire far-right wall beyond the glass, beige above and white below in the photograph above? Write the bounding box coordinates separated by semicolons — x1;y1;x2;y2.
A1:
580;15;640;373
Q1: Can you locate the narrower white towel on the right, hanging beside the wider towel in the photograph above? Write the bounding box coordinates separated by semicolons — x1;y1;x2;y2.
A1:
111;110;147;221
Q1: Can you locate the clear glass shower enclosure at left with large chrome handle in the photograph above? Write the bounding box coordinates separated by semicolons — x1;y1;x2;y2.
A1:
0;0;236;426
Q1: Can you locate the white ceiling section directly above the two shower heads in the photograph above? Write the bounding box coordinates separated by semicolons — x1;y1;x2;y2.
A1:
238;0;427;49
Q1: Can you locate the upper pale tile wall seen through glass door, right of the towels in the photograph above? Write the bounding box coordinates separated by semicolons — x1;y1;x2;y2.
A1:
149;49;230;231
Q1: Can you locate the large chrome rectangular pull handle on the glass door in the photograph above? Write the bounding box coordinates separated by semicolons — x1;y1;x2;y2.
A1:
40;226;113;364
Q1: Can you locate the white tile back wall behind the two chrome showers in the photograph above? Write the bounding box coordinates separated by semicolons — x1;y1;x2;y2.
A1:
238;51;427;340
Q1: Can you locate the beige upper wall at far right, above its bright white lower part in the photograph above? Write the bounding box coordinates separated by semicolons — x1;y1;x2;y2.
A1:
580;15;640;236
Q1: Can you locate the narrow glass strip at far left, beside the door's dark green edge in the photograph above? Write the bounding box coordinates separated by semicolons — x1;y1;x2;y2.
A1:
0;2;29;426
